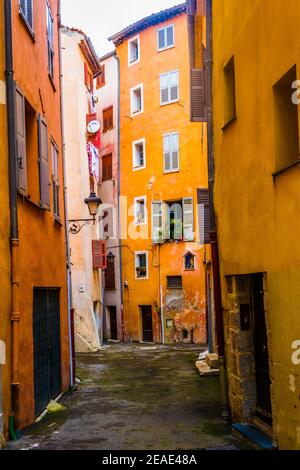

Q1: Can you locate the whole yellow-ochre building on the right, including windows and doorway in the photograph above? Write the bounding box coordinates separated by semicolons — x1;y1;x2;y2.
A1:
212;0;300;450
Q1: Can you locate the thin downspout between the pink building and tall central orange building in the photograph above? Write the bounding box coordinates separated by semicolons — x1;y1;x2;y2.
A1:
114;52;125;343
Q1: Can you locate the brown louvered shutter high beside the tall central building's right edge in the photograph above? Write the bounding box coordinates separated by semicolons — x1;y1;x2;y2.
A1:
191;69;207;122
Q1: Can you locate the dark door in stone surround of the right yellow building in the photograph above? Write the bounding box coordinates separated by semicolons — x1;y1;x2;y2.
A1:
251;274;272;424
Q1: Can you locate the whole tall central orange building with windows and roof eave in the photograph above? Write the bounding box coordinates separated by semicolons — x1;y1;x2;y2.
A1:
111;4;209;343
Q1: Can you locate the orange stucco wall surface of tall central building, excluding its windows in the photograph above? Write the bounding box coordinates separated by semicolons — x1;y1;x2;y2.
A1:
117;14;207;342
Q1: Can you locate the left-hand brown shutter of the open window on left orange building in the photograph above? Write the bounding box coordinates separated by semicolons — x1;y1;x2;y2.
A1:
15;87;27;196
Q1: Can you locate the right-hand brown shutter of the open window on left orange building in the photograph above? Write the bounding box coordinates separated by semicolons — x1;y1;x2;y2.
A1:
38;114;50;210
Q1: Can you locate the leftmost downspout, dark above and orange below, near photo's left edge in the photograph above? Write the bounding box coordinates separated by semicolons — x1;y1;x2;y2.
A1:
4;0;20;440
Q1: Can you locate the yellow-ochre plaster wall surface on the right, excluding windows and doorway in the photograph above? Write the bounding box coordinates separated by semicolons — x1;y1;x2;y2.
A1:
213;0;300;449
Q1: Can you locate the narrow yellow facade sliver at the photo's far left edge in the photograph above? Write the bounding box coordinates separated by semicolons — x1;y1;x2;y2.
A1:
0;2;11;448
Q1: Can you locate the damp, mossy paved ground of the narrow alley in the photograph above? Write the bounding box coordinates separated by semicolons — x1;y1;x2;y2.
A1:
8;345;246;450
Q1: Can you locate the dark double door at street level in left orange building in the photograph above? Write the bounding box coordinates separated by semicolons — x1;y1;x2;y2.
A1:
33;289;62;416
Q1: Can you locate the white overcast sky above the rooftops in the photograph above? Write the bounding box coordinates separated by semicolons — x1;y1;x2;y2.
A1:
62;0;183;56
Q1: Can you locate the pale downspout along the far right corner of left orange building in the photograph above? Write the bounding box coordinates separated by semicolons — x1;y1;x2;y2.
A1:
58;0;76;387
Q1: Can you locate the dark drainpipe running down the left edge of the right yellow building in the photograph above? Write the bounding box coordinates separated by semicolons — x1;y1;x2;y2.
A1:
206;0;229;419
